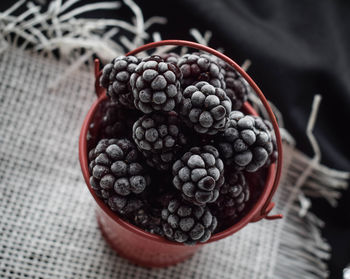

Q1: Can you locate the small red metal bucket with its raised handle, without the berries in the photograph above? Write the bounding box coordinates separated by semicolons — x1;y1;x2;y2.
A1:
79;40;282;267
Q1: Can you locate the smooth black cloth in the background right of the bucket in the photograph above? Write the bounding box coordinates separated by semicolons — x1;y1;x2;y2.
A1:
137;0;350;278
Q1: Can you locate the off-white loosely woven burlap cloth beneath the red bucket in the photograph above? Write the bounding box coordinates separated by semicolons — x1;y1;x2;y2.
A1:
0;48;344;279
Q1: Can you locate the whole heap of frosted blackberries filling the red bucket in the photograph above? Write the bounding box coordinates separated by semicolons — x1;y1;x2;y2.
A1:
87;53;277;245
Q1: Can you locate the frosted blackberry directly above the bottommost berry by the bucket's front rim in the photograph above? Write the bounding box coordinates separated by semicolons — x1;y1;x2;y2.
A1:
172;145;224;205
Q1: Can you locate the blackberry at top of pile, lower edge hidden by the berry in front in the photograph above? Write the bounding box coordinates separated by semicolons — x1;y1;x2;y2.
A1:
177;53;226;89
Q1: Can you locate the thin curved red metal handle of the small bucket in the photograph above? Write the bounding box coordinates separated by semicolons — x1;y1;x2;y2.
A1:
95;40;283;222
